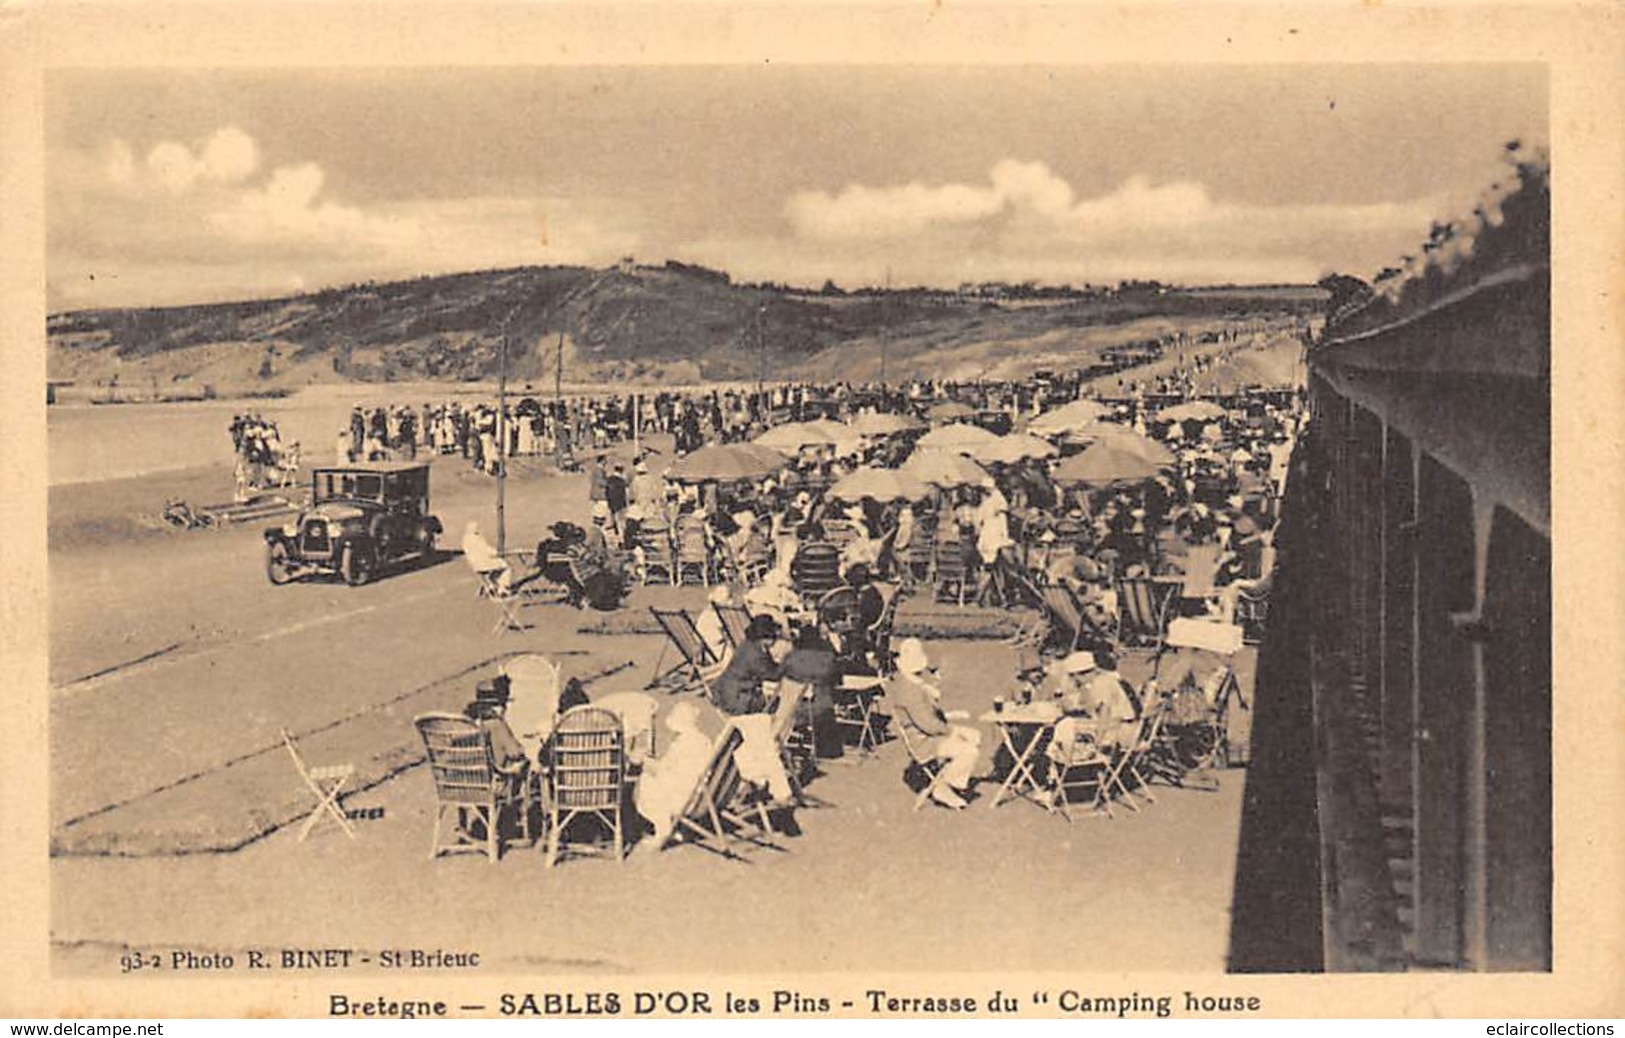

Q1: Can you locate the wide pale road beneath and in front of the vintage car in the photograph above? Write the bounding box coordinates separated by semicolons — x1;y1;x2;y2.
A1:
50;460;598;827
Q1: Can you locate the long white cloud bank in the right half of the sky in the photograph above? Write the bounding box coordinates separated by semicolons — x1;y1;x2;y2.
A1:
773;159;1443;286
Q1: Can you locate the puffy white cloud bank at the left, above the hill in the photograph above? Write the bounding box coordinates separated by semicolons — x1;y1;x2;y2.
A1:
49;127;644;307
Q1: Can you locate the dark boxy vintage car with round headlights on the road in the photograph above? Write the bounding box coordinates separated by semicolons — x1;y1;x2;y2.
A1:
265;461;440;585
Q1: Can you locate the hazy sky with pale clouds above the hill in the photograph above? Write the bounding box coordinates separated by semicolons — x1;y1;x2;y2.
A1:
46;63;1547;312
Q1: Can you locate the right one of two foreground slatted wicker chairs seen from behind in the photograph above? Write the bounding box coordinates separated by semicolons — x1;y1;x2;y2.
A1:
544;707;626;869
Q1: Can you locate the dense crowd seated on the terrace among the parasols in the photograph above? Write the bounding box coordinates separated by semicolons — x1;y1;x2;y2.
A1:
448;331;1305;846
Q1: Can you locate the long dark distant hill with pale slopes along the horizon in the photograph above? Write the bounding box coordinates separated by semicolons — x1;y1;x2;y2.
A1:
47;263;1324;391
